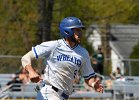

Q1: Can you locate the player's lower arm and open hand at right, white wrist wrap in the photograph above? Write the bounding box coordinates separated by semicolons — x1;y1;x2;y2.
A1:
85;77;103;93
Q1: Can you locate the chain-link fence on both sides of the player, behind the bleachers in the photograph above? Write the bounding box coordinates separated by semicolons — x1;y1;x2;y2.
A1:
0;55;139;76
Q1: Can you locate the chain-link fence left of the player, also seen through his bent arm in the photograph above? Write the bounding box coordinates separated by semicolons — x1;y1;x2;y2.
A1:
0;55;44;73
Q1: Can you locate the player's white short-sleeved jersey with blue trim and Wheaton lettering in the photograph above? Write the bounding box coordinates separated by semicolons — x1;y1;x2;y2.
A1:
32;39;95;94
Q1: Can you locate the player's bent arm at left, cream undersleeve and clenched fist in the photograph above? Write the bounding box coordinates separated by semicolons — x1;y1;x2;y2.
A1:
21;50;41;82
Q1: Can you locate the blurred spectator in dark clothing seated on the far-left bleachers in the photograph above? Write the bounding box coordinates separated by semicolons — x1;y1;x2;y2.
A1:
6;75;22;91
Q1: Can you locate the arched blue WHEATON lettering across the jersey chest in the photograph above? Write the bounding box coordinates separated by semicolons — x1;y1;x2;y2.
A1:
57;55;81;67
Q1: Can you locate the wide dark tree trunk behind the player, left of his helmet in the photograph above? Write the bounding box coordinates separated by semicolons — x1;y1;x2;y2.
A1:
38;0;54;42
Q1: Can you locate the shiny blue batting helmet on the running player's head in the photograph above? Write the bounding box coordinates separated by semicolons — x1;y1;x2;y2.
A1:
59;17;84;38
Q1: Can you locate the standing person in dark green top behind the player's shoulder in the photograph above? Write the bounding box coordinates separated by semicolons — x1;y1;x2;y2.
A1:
93;46;104;75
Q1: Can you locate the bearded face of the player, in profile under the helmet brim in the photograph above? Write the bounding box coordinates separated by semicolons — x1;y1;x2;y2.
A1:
73;28;82;43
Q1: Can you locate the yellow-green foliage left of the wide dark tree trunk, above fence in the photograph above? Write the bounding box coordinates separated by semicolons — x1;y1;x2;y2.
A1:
0;0;38;55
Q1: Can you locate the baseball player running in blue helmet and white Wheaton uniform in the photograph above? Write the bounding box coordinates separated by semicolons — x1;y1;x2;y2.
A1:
21;17;103;100
